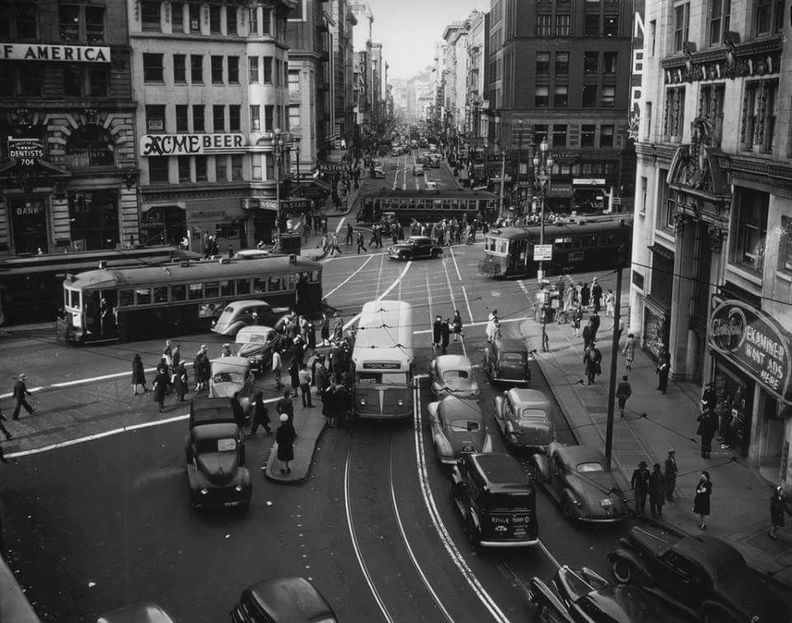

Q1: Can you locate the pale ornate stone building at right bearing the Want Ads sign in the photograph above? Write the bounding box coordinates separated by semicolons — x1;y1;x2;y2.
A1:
630;0;792;482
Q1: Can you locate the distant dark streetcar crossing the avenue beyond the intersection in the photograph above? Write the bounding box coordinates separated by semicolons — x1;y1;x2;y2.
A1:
357;188;498;224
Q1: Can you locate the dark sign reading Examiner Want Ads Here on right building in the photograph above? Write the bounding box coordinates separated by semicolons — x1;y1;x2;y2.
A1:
707;296;792;401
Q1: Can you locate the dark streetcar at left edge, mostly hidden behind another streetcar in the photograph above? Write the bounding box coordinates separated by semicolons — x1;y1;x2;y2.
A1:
0;245;201;325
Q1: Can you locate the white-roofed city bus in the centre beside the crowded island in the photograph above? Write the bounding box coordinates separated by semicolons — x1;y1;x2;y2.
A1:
352;301;415;420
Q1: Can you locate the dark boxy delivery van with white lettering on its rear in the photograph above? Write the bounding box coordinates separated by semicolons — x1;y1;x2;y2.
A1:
451;453;539;547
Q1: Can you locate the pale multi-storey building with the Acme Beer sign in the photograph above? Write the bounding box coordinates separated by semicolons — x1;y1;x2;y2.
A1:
127;0;297;252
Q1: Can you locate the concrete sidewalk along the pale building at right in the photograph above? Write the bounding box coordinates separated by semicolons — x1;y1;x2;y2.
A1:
521;315;792;588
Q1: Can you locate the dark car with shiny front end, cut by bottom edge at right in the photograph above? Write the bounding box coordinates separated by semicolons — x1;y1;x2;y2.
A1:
529;565;693;623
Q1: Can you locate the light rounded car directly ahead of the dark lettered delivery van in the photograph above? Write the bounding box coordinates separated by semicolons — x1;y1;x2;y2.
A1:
427;396;492;465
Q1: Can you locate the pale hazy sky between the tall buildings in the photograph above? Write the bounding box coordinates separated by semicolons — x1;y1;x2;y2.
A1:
355;0;490;78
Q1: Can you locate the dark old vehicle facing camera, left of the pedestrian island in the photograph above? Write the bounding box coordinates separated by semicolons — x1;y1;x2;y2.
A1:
184;398;253;509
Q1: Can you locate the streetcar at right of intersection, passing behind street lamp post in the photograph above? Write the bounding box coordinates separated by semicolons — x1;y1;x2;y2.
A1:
478;215;632;277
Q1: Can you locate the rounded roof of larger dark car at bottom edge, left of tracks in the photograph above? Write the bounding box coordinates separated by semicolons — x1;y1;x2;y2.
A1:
247;577;335;623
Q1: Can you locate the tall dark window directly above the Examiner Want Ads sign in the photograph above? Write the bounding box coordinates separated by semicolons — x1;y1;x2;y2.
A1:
729;186;770;274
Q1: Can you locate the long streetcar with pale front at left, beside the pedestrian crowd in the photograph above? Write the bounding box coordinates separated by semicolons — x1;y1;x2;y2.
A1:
58;255;322;343
